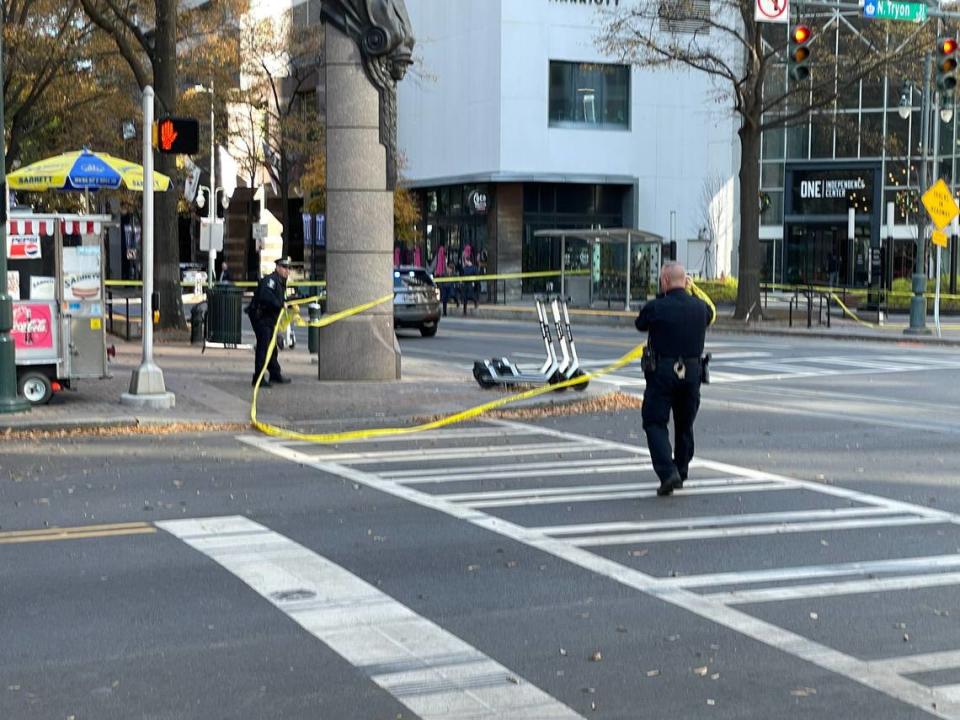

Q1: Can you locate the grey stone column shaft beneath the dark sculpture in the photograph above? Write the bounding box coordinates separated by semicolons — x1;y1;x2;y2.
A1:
318;22;400;380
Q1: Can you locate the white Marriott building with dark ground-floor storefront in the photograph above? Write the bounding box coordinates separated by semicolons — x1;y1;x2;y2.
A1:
398;0;739;301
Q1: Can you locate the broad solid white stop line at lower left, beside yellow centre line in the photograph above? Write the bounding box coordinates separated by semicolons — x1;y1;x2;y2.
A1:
157;516;582;720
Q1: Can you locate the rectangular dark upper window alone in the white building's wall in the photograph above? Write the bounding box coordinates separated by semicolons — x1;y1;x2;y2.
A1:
550;60;630;130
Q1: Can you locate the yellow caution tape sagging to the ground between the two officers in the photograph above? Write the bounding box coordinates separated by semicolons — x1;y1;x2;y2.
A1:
250;293;644;444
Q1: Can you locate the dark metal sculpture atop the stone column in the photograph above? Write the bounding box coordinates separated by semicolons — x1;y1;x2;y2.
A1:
321;0;415;190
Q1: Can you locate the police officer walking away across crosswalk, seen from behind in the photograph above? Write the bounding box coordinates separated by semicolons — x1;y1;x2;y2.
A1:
636;262;717;496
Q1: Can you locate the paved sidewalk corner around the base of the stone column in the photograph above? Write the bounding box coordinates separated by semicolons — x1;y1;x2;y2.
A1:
0;336;609;434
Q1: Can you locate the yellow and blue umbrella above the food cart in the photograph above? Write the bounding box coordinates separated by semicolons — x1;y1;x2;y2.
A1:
7;149;170;192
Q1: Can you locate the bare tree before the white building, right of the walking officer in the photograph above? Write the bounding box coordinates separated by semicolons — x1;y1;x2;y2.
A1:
599;0;932;319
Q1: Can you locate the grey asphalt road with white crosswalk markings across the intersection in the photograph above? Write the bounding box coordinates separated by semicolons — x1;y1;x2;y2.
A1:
0;318;960;720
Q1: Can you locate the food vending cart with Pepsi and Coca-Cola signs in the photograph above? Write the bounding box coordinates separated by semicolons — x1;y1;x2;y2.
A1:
7;214;111;405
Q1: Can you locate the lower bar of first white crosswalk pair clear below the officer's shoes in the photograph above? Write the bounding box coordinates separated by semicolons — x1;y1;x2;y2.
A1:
568;516;943;547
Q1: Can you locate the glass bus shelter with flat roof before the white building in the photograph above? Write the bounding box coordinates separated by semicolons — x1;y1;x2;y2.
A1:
533;228;663;310
